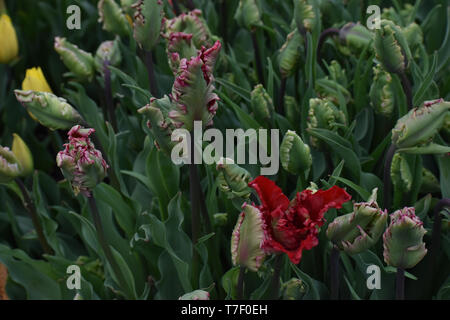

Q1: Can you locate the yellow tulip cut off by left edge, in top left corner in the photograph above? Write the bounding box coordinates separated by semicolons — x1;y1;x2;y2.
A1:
0;14;19;63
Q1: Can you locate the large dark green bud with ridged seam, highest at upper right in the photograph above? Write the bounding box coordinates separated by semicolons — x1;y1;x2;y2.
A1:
374;20;411;73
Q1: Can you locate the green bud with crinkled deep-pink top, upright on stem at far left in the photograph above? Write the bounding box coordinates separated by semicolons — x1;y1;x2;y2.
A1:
56;125;109;197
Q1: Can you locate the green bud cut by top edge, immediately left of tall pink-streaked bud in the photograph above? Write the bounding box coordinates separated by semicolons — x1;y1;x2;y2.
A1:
97;0;131;36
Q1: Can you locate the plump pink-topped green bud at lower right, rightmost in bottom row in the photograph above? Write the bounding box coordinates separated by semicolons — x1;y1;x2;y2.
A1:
383;207;427;269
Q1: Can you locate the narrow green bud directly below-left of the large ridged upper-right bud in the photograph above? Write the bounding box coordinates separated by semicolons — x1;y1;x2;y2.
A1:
369;65;395;118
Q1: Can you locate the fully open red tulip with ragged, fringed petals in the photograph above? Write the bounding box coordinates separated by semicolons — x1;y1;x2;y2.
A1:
249;176;351;264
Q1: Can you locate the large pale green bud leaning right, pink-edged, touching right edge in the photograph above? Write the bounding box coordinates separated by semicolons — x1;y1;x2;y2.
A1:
392;99;450;148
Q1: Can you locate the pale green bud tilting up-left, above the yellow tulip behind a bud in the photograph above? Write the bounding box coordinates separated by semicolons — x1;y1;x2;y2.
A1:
55;37;95;81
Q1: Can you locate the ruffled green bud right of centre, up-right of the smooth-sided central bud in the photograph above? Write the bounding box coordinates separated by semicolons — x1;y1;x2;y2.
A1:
307;98;347;148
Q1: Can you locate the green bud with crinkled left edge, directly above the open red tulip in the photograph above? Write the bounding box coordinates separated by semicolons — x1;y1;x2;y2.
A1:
280;130;312;175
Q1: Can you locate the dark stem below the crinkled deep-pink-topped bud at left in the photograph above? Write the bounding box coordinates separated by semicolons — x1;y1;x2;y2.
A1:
88;196;128;298
